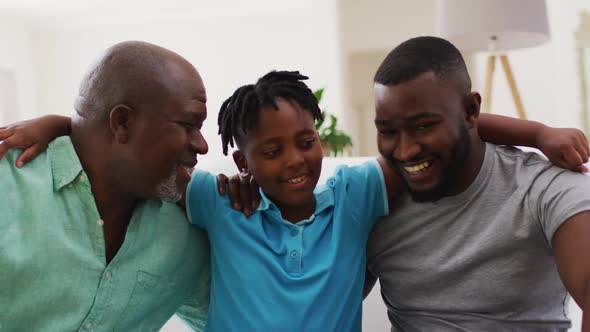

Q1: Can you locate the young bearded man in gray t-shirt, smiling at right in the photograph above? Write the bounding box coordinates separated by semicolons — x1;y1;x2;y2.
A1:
367;37;590;331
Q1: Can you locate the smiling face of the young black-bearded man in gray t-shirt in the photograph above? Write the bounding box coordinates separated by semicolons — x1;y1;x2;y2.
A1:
375;72;479;201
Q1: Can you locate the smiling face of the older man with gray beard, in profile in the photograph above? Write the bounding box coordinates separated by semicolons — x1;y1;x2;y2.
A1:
125;61;208;202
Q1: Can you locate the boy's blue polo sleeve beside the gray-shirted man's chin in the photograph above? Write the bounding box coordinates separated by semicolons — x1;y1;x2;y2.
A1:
328;160;389;226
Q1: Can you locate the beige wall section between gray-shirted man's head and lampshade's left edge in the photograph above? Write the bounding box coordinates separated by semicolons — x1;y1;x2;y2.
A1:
339;0;435;156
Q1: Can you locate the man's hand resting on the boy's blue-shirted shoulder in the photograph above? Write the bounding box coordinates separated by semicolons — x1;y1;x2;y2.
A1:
217;174;260;217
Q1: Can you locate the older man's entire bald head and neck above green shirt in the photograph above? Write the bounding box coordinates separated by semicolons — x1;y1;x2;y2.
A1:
13;42;213;263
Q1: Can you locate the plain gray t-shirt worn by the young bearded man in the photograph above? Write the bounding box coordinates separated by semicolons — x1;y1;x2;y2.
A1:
367;144;590;331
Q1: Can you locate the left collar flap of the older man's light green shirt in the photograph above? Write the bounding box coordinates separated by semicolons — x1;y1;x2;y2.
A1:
47;136;84;191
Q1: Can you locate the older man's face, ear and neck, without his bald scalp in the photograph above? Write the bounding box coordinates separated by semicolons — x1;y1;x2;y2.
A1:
95;58;208;262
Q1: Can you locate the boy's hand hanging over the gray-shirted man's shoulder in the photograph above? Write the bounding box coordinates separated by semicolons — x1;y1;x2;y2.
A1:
537;127;590;172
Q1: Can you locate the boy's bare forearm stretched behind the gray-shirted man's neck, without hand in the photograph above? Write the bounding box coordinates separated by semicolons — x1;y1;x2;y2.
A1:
478;114;546;148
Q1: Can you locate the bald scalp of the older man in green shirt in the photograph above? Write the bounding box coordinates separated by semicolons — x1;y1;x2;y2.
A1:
74;41;200;120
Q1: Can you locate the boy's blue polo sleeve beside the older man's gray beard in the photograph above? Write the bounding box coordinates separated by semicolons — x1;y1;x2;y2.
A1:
186;170;221;229
